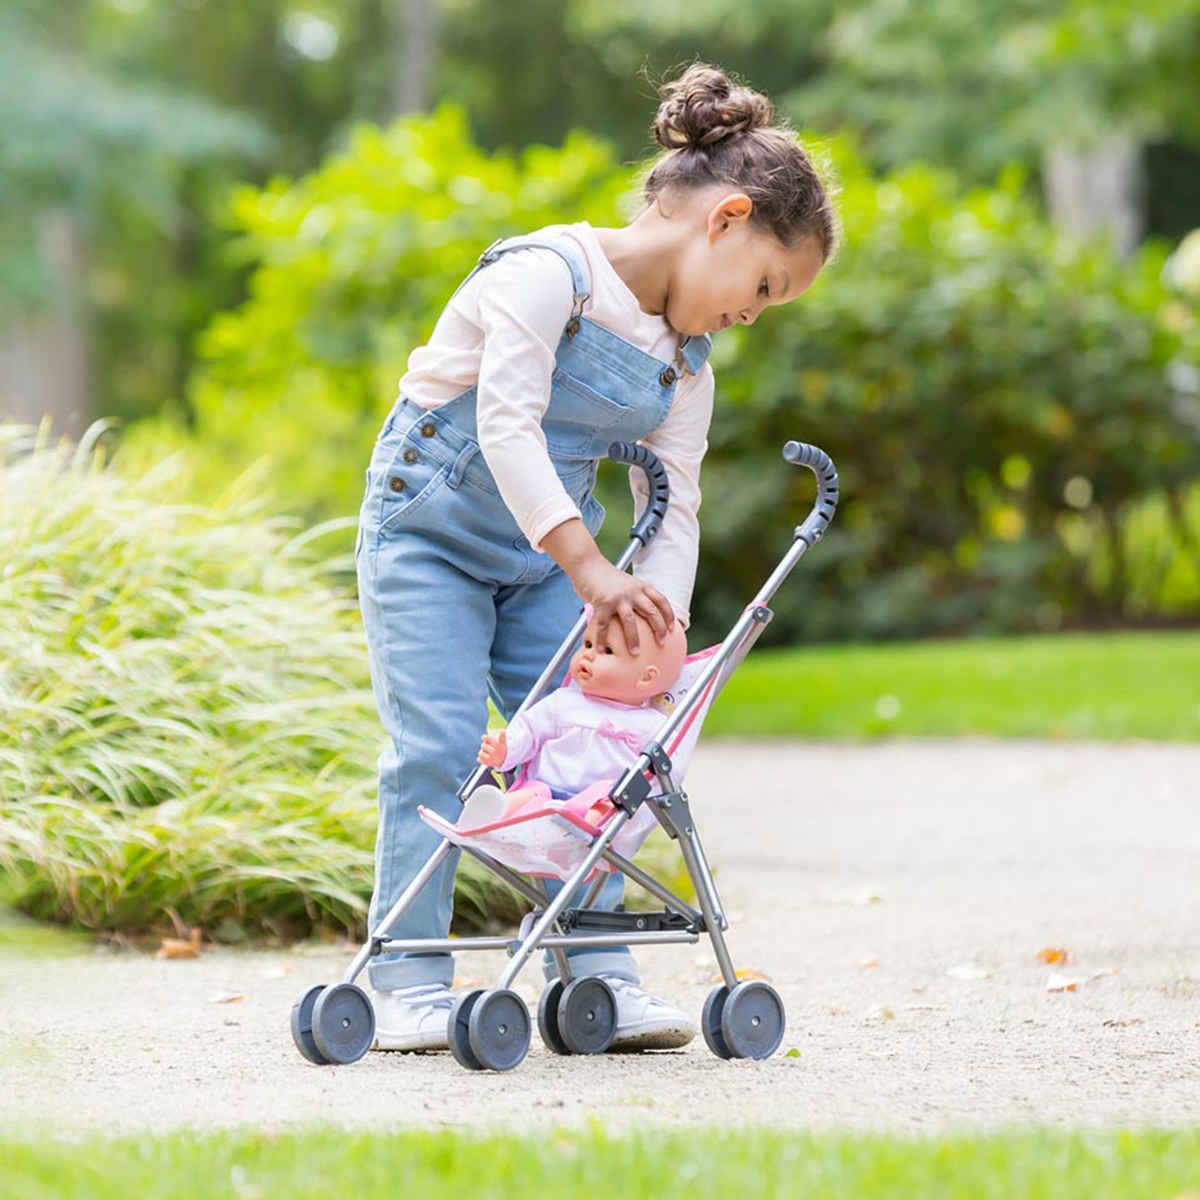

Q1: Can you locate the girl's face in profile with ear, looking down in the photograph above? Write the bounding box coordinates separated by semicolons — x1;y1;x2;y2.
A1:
665;188;824;336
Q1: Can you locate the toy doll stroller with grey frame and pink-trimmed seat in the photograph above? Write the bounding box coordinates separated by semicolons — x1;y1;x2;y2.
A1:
292;442;838;1070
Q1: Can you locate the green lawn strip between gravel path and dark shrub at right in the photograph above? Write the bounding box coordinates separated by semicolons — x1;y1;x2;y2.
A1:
706;632;1200;742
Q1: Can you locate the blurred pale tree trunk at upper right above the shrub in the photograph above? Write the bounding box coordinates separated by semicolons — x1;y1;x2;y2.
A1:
1042;132;1145;258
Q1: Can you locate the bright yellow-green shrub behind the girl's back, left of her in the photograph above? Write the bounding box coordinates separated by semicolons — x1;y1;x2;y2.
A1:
120;108;628;516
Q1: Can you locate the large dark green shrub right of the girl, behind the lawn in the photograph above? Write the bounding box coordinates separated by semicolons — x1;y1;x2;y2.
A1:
697;154;1200;641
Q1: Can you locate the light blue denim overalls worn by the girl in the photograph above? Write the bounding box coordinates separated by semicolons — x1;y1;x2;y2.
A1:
355;236;709;990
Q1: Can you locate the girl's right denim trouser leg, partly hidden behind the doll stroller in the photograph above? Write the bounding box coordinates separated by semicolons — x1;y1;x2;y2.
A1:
490;569;638;983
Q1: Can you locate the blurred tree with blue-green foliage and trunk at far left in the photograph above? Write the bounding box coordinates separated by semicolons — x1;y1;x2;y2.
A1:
0;2;265;428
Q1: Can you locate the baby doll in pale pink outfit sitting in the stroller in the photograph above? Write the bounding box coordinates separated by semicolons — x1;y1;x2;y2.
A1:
458;617;688;829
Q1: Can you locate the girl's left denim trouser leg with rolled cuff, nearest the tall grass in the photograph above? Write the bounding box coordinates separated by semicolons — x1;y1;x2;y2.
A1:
358;534;496;991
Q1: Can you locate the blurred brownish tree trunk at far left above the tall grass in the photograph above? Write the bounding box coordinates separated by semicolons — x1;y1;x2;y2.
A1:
0;211;92;437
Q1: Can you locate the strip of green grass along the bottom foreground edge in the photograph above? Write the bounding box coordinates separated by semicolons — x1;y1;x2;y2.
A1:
0;1128;1200;1200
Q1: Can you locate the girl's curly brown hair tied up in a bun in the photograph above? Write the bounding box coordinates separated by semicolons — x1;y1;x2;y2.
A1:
642;62;838;262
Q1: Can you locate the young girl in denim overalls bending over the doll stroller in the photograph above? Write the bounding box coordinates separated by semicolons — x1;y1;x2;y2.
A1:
356;66;835;1050
